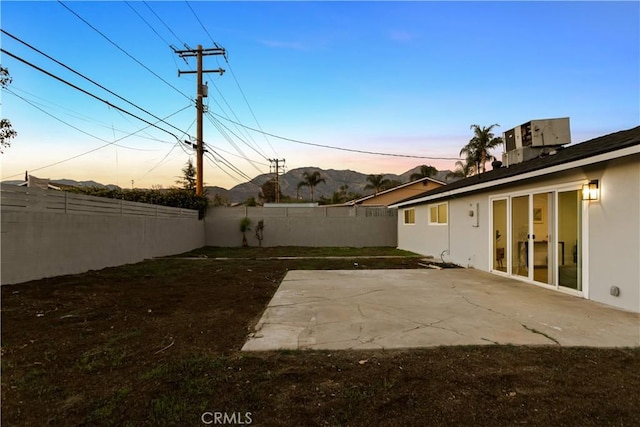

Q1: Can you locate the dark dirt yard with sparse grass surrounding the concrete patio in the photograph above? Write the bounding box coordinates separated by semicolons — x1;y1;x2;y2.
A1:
1;248;640;426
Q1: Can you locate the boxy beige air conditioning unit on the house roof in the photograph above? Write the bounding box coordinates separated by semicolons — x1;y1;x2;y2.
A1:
502;117;571;167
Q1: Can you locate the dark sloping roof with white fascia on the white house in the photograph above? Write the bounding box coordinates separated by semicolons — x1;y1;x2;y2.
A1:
391;126;640;207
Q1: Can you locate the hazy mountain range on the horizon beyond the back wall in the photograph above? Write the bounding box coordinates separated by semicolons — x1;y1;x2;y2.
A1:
206;166;458;203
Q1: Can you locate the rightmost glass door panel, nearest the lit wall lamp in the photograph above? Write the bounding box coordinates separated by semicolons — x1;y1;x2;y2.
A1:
557;190;582;291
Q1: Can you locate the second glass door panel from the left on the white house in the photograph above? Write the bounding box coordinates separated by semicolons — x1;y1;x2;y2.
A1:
511;195;529;277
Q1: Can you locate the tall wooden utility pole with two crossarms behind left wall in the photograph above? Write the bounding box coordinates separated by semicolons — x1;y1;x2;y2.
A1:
174;45;227;196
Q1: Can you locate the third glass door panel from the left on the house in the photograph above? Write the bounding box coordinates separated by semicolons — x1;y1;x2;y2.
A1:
529;193;554;284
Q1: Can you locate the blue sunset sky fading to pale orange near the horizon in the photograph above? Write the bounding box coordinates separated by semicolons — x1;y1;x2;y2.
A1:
0;0;640;188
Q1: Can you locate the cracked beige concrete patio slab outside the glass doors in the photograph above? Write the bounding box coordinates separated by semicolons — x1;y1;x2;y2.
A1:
243;269;640;351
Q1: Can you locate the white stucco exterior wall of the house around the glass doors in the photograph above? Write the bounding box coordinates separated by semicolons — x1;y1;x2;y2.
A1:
398;155;640;312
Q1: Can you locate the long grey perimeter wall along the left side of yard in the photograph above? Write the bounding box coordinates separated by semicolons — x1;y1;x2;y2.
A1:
0;209;204;285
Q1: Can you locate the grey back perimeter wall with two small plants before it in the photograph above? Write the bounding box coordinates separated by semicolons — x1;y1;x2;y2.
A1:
205;206;398;247
